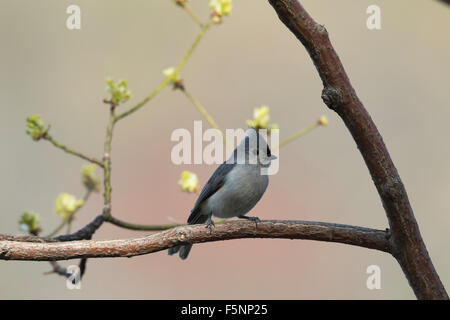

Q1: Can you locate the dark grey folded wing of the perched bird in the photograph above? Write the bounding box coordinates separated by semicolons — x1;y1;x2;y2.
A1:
188;162;235;224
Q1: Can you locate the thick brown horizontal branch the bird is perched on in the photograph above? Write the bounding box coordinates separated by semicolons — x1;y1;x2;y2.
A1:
0;220;390;261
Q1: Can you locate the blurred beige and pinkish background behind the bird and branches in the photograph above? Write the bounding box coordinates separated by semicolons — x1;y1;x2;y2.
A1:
0;0;450;299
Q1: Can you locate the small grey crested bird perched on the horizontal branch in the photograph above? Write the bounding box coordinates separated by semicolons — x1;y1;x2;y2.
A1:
168;128;277;260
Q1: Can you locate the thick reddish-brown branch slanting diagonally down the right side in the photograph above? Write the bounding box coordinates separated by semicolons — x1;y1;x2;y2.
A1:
269;0;448;299
